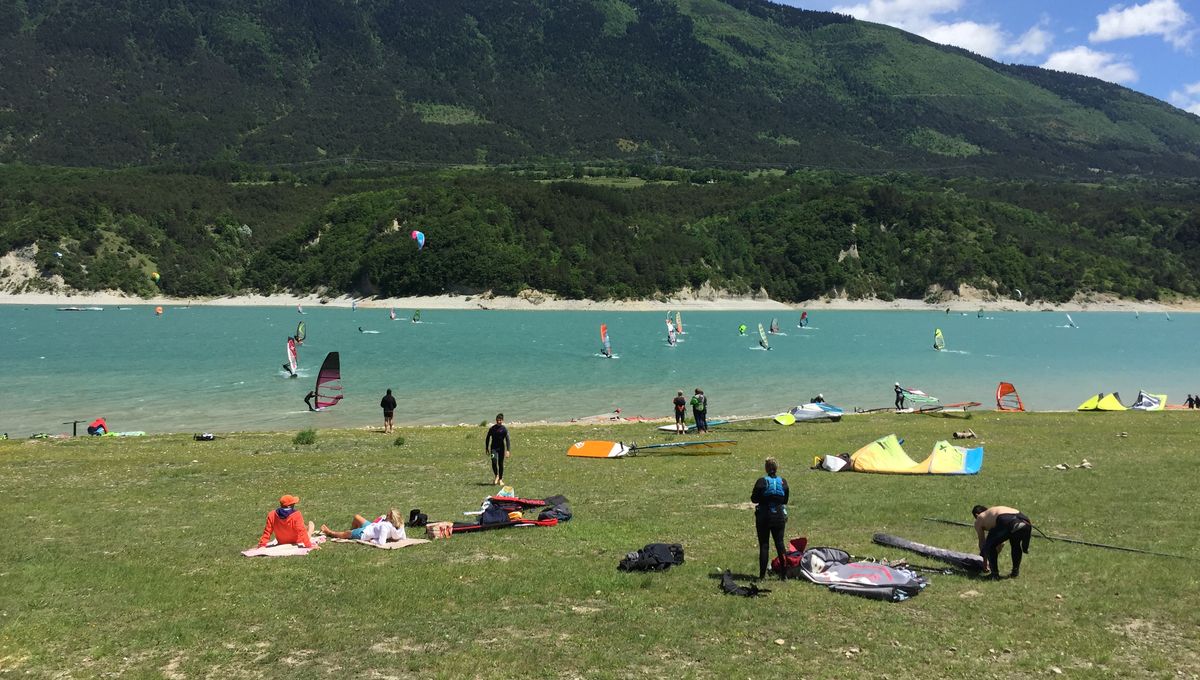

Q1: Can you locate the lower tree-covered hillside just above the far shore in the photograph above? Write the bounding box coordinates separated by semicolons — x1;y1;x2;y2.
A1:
0;167;1200;301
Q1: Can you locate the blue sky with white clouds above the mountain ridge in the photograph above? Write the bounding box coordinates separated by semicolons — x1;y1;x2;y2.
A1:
775;0;1200;115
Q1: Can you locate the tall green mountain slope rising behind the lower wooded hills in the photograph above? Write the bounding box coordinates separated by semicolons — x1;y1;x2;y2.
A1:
0;0;1200;176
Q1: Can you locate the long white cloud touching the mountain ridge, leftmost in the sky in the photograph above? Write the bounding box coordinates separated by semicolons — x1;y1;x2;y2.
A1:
833;0;1054;58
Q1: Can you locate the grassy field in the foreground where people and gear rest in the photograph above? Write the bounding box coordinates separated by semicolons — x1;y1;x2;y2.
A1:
0;413;1200;678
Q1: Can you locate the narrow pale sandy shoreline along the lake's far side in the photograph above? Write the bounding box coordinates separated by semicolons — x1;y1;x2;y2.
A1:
0;293;1200;313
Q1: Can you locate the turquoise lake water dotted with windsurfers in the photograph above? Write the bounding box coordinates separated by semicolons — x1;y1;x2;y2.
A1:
0;305;1200;437
